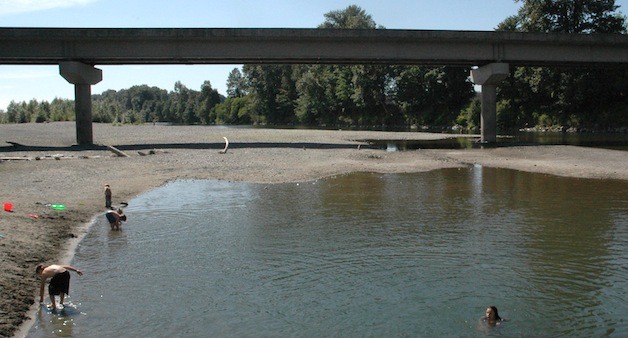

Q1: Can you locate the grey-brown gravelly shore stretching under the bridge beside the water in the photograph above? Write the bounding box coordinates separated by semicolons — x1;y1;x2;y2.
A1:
0;122;628;337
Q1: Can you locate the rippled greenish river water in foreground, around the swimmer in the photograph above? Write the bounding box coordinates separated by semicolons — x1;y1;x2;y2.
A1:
29;166;628;337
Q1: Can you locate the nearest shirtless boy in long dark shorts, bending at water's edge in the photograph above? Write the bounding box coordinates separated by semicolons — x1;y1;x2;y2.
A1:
35;264;83;310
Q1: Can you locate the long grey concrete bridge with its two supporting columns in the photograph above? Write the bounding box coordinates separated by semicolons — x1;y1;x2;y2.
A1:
0;28;628;144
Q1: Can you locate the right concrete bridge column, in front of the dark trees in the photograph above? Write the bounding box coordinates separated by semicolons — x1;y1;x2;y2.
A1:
471;63;510;143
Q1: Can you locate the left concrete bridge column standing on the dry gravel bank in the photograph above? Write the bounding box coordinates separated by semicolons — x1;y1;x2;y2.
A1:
59;61;102;145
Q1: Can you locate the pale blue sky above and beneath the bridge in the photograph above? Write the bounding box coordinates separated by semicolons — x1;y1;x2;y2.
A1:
0;0;628;109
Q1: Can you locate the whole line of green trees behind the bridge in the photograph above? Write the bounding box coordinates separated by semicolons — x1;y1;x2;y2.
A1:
0;0;628;130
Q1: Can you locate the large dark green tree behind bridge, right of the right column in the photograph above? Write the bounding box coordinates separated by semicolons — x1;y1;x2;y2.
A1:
497;0;628;128
